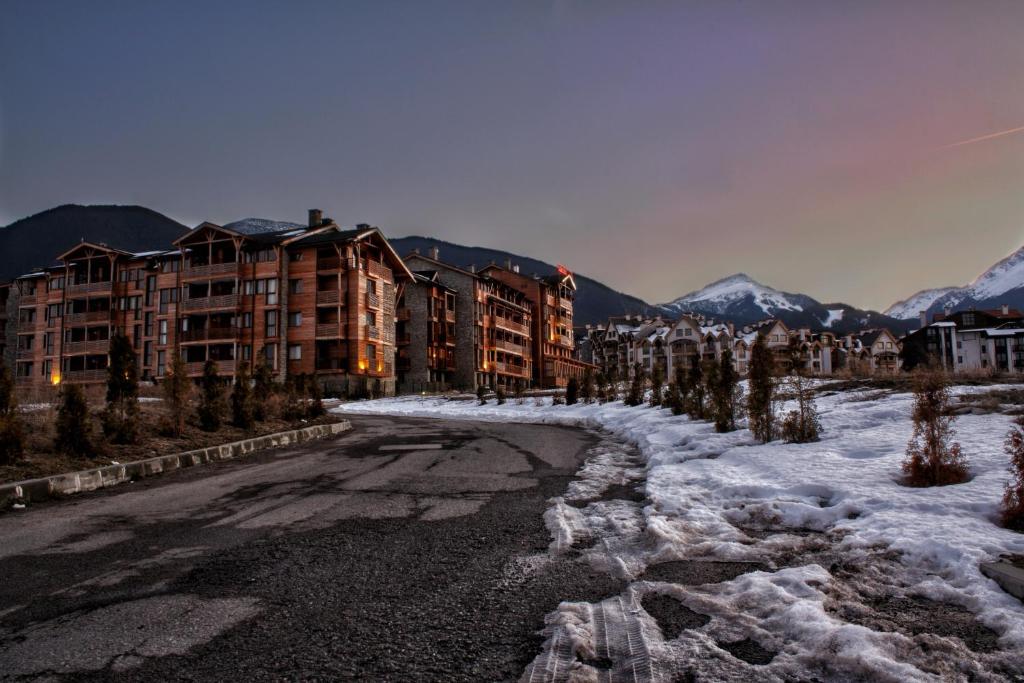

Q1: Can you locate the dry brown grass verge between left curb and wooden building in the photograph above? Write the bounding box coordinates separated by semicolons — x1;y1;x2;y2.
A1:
0;391;340;489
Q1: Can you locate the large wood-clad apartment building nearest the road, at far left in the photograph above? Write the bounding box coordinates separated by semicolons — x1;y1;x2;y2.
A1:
0;210;413;393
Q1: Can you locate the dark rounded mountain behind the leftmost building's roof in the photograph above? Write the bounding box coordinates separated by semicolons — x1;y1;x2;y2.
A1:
0;204;188;281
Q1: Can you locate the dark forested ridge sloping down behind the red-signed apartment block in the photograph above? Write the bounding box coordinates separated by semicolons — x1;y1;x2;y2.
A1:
389;237;664;326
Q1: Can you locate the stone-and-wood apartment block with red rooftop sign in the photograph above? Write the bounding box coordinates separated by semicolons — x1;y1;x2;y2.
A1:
396;247;592;391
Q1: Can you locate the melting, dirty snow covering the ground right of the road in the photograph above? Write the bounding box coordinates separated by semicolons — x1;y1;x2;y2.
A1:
335;387;1024;681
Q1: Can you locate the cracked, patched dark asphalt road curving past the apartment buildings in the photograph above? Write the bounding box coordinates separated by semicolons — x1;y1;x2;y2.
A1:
0;416;623;681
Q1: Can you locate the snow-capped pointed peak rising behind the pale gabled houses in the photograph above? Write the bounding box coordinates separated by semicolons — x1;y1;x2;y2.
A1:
660;272;907;333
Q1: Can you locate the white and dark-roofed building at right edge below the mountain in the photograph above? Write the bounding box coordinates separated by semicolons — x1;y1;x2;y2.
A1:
902;305;1024;375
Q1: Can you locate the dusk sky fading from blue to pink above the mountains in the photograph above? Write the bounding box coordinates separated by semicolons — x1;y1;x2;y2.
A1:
0;0;1024;309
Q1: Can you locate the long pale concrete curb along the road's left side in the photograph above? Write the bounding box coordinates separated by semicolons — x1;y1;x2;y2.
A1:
0;420;352;510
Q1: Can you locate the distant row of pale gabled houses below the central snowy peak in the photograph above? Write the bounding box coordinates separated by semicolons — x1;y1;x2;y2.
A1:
581;314;900;378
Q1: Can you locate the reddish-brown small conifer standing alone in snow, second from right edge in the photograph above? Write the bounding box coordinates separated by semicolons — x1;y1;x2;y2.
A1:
903;369;968;486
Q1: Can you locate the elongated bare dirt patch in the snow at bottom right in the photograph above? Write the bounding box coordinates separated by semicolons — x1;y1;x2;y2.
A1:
837;597;999;652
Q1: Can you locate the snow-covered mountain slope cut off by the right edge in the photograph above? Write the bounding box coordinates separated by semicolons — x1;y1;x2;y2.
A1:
886;247;1024;319
